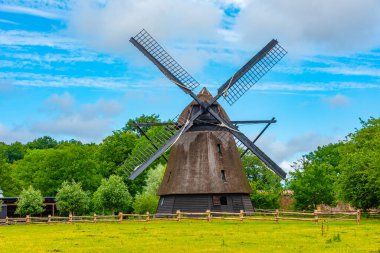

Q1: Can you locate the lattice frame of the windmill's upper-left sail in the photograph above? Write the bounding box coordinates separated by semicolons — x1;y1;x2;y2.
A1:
133;29;199;90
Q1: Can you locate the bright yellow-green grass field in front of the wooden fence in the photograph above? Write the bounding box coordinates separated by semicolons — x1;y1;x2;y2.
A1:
0;220;380;253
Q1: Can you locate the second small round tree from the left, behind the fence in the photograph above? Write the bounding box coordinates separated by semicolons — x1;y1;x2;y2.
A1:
55;181;90;215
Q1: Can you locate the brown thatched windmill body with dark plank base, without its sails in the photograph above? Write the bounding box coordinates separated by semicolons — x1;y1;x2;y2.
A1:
157;88;252;213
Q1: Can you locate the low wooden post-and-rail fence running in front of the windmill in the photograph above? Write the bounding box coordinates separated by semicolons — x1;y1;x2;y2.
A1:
0;209;360;225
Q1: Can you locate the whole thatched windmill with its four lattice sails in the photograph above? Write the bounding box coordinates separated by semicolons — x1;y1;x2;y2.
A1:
122;29;286;213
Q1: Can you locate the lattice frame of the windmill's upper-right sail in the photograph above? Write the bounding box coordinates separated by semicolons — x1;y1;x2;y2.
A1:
223;41;287;105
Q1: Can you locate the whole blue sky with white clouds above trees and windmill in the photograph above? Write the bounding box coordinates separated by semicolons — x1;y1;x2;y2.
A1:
0;0;380;170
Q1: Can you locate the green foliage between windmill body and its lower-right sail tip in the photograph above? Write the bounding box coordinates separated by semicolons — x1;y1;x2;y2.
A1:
243;155;283;209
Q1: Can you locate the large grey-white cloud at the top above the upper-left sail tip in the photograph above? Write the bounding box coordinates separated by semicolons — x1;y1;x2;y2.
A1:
69;0;222;53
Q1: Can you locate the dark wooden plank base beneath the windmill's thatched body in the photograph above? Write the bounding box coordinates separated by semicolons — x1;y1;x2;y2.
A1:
157;194;253;213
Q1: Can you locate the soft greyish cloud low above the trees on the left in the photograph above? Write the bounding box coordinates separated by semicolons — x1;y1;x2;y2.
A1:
30;92;122;142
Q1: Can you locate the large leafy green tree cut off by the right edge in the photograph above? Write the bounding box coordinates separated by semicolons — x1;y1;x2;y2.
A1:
338;118;380;209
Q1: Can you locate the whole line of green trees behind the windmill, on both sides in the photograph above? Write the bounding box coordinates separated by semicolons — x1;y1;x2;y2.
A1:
0;114;380;214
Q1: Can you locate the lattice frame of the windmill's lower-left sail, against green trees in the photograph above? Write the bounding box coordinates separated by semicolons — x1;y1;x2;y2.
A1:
121;115;187;175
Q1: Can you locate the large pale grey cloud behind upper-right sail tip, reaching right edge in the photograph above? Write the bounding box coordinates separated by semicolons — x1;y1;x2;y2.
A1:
235;0;380;55
